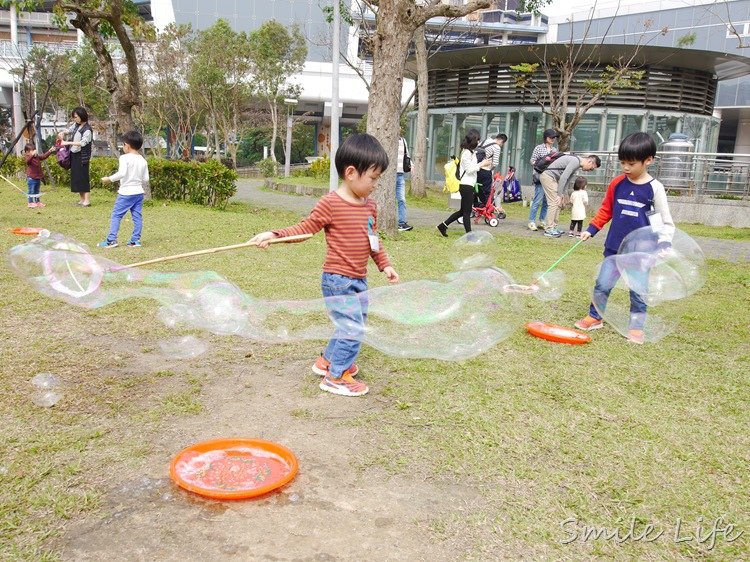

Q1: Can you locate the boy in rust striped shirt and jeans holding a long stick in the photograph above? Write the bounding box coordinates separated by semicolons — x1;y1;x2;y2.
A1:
251;134;398;396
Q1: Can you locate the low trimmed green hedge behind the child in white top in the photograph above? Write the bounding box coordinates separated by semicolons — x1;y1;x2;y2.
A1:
0;156;237;207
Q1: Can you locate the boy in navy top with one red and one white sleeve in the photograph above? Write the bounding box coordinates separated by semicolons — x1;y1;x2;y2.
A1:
575;133;674;344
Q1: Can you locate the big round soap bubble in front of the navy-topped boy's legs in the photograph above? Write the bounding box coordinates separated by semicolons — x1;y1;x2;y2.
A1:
592;226;706;342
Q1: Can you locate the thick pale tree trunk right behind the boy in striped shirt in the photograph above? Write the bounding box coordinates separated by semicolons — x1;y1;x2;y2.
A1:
367;24;412;235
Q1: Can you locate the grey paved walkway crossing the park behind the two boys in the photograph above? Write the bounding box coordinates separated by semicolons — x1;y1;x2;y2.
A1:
232;178;750;263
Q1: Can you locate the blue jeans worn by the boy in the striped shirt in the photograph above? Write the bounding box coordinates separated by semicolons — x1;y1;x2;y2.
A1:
321;273;369;379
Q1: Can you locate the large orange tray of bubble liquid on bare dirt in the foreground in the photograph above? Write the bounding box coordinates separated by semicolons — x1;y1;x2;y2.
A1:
169;438;298;500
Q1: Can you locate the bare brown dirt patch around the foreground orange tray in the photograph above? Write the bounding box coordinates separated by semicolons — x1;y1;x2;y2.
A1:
55;338;481;561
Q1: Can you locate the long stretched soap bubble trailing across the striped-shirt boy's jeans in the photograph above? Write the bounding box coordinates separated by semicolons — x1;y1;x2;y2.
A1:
10;231;564;361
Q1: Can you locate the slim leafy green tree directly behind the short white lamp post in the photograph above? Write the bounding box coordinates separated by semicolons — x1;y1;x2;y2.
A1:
250;20;307;161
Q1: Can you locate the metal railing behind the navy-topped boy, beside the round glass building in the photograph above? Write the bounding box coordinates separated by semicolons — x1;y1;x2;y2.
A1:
579;152;750;199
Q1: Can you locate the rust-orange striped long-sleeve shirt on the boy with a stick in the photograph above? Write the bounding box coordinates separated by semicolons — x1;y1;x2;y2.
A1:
273;191;391;279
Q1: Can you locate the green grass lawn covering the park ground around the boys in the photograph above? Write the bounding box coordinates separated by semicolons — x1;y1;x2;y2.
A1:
0;182;750;560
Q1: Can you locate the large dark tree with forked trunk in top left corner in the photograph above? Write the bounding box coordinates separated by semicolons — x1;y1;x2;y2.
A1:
0;0;154;136
